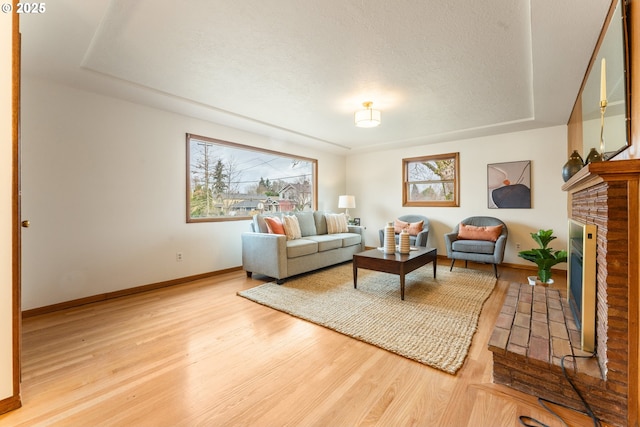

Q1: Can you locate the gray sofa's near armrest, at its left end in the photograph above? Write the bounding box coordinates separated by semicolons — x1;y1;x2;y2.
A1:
242;232;287;279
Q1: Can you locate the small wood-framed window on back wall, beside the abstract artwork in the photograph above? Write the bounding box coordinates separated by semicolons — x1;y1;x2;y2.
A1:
402;153;460;206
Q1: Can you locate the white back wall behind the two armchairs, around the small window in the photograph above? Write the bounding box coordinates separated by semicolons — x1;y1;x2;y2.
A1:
347;126;567;269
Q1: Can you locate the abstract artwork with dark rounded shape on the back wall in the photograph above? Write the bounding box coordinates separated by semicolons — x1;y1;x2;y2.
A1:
487;160;531;209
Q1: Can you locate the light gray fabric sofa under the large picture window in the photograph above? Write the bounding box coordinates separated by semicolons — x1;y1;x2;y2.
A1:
242;211;365;284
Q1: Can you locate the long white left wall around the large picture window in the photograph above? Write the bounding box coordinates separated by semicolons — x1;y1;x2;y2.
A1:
22;76;345;310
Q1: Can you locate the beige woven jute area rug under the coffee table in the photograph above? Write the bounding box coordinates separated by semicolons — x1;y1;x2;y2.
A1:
238;263;496;374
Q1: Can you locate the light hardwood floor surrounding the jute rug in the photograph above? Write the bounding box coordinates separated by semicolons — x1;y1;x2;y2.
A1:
0;264;608;427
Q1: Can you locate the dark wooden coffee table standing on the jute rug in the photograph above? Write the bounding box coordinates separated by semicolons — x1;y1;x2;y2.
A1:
353;247;438;300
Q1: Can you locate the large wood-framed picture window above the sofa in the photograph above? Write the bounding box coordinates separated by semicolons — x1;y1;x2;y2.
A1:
187;134;318;222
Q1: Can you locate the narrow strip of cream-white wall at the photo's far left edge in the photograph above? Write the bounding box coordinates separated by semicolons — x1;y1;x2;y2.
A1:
0;5;13;400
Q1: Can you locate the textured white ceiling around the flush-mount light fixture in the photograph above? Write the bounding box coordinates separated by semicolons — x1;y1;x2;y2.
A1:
21;0;610;152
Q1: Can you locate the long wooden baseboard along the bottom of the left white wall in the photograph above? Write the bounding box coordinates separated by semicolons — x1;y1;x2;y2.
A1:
22;267;242;319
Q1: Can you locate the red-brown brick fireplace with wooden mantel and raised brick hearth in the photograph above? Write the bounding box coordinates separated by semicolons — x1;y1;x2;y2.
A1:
489;160;640;426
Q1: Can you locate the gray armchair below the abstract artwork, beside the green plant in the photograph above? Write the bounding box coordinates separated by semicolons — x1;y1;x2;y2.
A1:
444;216;509;278
